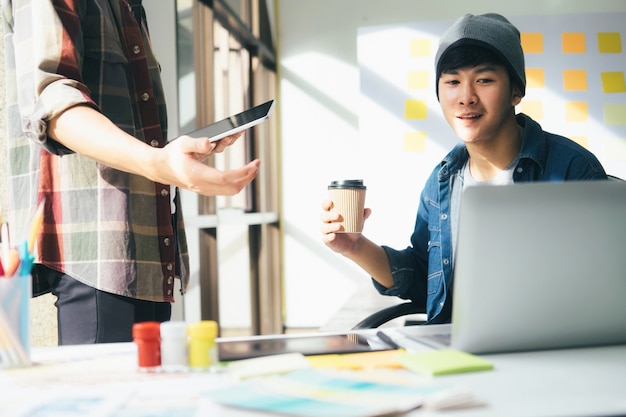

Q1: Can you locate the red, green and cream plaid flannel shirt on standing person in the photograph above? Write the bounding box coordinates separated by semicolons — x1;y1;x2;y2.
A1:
2;0;189;301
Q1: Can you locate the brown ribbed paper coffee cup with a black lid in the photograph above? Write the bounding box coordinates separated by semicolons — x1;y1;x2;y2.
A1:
328;180;366;233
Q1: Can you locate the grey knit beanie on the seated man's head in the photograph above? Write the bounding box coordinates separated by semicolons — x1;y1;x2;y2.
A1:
435;13;526;98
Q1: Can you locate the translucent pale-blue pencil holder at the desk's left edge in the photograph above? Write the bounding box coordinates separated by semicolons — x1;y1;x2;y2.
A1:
0;274;32;368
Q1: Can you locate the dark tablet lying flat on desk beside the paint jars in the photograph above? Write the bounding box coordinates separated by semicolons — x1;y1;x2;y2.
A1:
217;333;393;361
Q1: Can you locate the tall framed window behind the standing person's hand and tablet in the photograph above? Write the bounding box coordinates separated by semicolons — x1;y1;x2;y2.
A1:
177;0;283;334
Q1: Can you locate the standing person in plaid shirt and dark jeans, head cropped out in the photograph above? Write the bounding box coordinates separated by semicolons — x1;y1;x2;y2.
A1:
2;0;259;344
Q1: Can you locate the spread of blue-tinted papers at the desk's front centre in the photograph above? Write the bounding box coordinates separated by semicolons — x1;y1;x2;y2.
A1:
211;368;479;417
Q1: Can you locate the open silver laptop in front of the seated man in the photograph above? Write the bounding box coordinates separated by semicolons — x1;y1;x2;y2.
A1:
392;181;626;354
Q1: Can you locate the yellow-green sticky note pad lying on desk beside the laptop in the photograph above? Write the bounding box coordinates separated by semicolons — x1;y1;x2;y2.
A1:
398;349;493;376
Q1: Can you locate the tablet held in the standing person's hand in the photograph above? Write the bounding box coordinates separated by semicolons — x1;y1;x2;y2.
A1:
187;100;274;142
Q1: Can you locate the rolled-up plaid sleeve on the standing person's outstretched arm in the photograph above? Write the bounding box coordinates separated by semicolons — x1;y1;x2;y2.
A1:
9;0;98;154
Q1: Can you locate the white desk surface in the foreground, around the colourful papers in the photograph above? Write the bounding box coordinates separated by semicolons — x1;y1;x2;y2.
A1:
0;330;626;417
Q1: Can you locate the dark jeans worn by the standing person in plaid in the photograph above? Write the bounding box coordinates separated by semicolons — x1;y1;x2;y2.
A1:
36;265;172;345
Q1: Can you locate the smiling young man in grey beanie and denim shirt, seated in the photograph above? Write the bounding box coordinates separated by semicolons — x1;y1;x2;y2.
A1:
321;13;607;323
